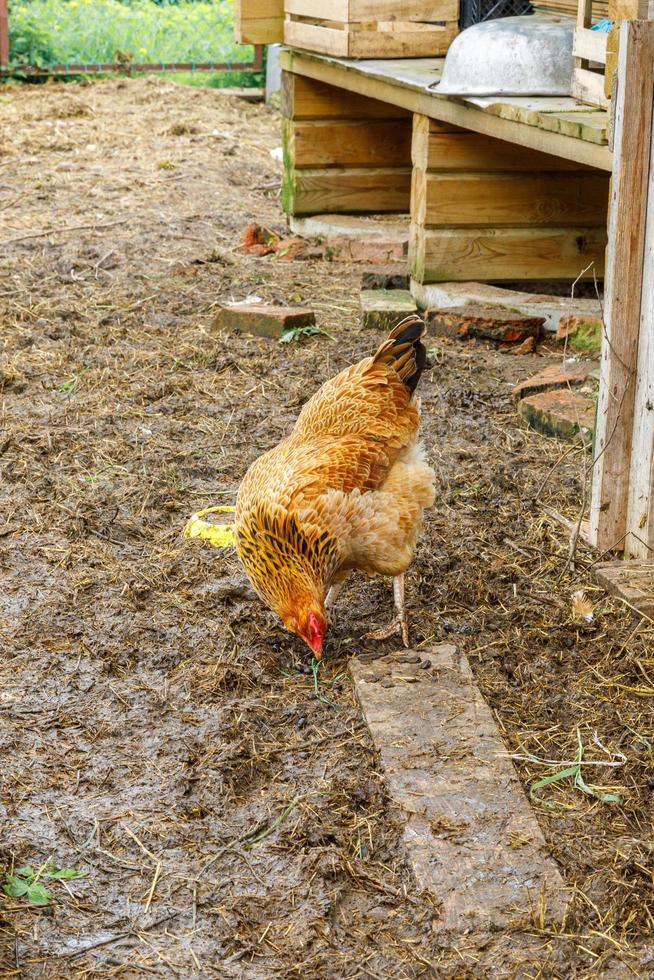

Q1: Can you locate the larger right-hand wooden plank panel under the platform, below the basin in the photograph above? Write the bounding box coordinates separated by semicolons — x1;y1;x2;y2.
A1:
409;115;610;284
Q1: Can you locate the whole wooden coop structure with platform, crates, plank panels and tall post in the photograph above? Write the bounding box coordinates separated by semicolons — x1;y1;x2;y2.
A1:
236;0;654;588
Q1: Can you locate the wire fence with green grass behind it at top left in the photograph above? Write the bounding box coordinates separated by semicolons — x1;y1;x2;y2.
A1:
0;0;263;75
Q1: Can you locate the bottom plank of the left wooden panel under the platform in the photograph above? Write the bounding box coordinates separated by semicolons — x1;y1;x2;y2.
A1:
282;167;411;214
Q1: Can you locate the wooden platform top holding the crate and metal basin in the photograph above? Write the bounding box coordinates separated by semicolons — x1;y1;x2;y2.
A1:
282;49;612;171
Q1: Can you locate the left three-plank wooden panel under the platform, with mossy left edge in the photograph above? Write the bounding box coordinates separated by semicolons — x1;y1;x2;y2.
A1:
282;72;411;215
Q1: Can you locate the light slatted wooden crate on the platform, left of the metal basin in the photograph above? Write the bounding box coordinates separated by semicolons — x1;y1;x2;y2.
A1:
284;0;459;58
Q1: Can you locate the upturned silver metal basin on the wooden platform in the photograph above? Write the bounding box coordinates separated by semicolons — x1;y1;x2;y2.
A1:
433;15;574;96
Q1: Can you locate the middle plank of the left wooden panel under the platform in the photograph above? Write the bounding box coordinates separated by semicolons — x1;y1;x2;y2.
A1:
288;118;411;168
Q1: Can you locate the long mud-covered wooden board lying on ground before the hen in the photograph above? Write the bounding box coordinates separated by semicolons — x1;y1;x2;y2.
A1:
350;644;567;934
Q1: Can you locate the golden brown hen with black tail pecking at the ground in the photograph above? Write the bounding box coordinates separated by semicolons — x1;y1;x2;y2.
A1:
235;316;434;657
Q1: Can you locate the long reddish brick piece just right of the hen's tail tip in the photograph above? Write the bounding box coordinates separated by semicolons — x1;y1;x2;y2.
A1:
425;306;545;344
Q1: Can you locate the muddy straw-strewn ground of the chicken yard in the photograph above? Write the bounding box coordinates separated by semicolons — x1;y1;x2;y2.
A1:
0;79;654;980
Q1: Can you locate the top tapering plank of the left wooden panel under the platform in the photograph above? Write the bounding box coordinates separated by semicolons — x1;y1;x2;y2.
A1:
282;71;411;119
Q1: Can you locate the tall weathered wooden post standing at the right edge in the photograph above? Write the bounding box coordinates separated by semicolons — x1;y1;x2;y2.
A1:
590;21;654;550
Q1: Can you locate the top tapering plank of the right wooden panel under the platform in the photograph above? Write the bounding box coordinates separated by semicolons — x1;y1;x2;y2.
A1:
411;114;604;172
